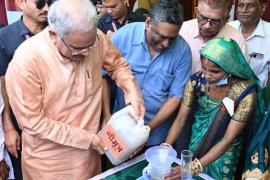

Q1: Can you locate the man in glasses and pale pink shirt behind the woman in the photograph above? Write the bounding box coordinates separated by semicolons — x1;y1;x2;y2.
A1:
179;0;247;73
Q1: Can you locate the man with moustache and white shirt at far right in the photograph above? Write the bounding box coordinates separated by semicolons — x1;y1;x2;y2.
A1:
229;0;270;103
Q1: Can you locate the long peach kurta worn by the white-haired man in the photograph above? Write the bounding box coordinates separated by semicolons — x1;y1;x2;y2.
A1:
6;29;136;180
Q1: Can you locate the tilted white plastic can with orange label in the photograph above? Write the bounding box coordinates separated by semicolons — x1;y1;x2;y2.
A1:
100;106;150;165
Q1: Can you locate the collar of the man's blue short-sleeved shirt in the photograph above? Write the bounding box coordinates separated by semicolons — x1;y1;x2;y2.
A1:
132;22;176;53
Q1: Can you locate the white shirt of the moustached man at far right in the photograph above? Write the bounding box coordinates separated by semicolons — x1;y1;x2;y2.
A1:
229;19;270;88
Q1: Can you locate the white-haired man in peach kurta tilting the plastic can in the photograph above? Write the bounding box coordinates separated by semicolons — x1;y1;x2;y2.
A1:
6;0;144;180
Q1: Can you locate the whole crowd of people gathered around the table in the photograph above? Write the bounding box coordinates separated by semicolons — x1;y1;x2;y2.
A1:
0;0;270;180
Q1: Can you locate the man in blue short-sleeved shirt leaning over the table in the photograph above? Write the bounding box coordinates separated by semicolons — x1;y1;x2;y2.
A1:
111;0;191;146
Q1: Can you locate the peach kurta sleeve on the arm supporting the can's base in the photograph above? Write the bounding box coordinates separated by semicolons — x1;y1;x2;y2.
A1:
6;58;93;149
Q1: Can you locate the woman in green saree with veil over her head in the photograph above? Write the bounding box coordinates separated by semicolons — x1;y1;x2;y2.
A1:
165;38;263;180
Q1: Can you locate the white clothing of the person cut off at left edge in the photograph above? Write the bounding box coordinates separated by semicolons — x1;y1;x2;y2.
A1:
0;80;14;179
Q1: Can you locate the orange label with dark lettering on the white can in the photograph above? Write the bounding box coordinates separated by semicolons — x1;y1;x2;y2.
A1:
100;124;127;158
